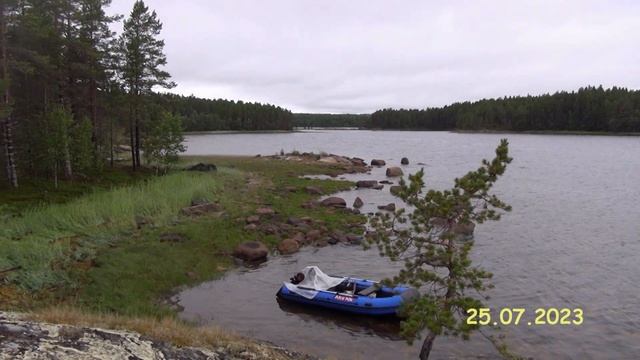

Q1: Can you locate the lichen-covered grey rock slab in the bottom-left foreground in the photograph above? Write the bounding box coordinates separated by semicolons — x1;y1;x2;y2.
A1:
0;312;313;360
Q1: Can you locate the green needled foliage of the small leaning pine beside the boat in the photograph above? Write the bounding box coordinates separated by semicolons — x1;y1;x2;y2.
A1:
368;139;511;356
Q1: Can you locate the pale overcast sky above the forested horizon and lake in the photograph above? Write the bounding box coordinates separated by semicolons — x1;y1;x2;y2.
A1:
110;0;640;113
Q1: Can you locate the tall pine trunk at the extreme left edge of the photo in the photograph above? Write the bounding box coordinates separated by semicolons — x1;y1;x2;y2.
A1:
0;1;18;188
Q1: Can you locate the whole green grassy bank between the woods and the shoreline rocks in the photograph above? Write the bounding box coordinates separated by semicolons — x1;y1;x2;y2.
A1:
0;157;362;317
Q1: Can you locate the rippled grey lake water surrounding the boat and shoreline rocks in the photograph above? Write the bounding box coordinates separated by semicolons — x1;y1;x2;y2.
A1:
177;130;640;359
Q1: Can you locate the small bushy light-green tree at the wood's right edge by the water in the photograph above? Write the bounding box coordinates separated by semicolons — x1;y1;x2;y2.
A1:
144;112;185;170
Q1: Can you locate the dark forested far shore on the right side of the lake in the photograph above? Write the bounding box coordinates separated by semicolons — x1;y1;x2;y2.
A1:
370;86;640;132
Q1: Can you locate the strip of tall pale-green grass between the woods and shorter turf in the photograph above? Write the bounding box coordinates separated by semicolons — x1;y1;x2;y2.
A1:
0;172;230;290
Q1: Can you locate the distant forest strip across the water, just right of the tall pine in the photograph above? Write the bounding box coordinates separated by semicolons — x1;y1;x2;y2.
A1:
151;94;293;131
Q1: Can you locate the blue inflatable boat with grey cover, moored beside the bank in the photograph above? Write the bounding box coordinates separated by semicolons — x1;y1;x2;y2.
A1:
277;266;418;316
